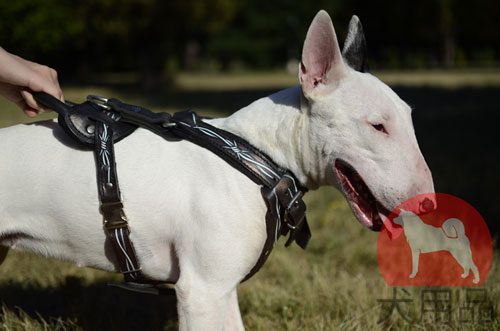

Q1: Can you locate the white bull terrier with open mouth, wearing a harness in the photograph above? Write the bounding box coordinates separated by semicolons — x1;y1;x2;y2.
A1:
0;11;434;330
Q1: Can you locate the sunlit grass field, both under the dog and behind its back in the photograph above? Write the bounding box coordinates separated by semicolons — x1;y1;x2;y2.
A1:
0;71;500;331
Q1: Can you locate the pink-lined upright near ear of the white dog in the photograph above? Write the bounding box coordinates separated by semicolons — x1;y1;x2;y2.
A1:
299;10;345;99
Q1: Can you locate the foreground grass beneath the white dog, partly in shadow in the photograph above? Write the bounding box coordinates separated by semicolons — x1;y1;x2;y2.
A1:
0;189;500;330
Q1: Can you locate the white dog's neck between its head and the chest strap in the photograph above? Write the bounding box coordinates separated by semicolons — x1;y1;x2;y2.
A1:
211;86;319;189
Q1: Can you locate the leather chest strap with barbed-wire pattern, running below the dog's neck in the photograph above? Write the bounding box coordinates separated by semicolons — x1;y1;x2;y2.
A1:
172;111;311;281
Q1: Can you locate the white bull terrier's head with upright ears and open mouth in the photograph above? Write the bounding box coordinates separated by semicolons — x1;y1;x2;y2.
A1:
299;11;436;230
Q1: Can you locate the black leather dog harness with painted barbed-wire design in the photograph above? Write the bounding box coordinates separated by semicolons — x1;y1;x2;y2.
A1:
34;92;311;284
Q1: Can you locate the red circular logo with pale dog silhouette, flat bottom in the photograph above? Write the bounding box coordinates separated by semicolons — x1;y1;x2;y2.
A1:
377;193;493;286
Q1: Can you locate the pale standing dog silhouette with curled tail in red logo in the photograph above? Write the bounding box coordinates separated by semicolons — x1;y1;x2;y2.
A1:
394;209;479;284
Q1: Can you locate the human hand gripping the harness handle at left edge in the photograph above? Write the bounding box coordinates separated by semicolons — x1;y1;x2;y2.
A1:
0;47;64;117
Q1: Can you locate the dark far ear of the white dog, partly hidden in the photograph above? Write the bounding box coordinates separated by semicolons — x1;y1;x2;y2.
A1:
342;15;370;72
